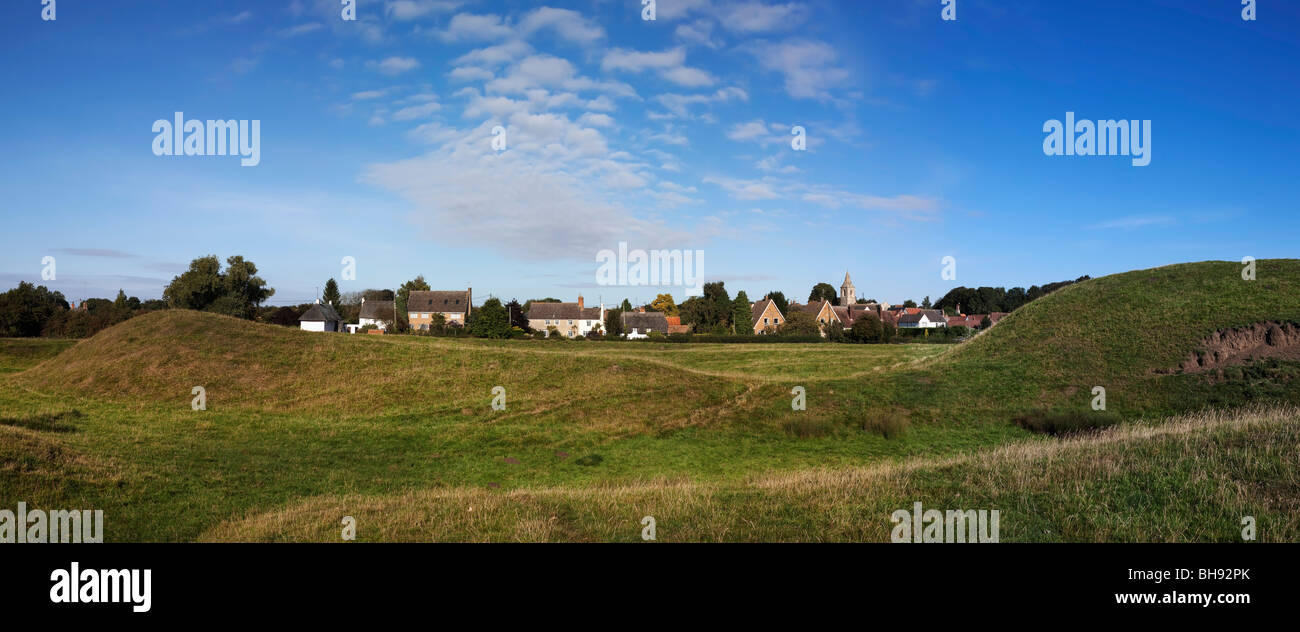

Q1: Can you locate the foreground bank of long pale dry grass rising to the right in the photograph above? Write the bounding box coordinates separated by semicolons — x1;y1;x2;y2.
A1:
203;408;1300;542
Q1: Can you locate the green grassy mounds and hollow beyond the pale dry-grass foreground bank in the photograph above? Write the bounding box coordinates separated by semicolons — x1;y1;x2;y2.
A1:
0;260;1300;540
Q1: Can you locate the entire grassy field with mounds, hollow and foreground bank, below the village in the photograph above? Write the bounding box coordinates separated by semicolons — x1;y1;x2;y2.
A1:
0;260;1300;541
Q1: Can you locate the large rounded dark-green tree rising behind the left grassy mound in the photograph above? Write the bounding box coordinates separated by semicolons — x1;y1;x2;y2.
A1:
163;255;276;320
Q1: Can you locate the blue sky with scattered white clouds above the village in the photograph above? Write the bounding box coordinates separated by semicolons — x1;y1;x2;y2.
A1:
0;0;1300;304
